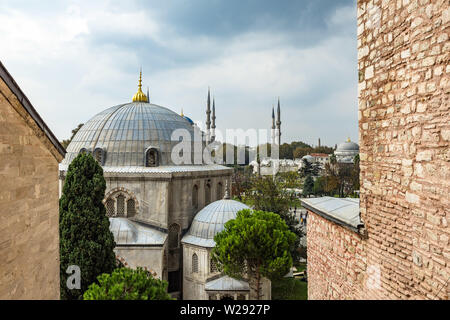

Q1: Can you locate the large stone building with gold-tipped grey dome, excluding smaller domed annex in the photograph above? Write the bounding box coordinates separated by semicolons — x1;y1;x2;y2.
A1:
59;74;232;297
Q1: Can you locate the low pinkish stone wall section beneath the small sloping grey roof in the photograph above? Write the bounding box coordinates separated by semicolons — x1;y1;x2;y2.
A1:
306;211;372;300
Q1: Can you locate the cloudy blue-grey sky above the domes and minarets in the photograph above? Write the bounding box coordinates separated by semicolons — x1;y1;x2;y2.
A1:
0;0;358;146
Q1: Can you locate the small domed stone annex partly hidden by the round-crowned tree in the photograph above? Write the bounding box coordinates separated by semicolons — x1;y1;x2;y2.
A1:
181;185;271;300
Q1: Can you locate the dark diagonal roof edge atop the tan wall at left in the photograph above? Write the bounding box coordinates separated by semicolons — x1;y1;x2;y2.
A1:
0;61;66;157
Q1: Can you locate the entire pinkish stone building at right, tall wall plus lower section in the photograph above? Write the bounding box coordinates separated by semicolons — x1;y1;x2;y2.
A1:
307;0;450;299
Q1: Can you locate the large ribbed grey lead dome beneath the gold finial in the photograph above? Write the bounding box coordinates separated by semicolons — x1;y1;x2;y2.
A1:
62;102;201;167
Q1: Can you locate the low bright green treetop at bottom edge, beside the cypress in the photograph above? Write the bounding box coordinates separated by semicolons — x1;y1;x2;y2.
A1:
83;267;172;300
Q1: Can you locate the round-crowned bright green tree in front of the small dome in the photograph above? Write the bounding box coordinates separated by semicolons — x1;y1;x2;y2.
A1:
212;209;295;300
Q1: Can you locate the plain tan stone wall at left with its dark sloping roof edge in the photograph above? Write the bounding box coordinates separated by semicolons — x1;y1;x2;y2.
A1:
0;63;65;299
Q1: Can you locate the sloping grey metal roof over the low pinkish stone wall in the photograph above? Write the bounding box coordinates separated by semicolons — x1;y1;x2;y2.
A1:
300;197;363;231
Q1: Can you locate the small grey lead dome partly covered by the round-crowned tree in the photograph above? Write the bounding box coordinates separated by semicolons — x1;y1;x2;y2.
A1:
182;199;250;248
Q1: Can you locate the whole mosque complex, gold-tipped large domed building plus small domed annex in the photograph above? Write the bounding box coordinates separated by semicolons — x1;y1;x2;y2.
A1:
59;72;270;299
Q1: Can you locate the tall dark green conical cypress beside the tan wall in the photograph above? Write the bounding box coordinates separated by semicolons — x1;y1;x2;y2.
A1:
59;153;116;299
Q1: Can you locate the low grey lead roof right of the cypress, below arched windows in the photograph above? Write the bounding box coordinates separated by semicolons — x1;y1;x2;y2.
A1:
109;218;167;246
